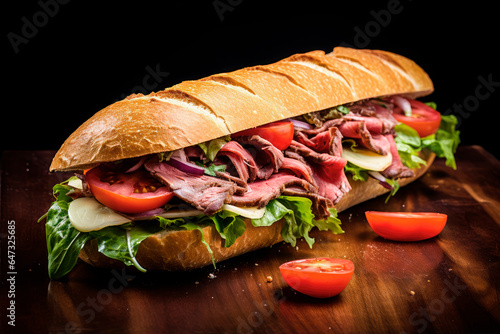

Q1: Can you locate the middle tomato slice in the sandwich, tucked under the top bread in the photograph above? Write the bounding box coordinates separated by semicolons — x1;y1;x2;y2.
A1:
231;121;293;151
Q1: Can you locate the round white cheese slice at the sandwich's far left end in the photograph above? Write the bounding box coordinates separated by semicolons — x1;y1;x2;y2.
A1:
68;197;131;232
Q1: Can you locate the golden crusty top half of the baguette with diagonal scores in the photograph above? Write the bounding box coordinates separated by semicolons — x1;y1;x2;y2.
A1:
50;47;434;171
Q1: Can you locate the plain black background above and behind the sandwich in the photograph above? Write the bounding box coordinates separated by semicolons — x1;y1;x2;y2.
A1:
0;0;500;158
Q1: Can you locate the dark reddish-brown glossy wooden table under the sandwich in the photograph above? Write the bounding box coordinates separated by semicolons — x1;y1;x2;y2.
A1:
1;146;500;333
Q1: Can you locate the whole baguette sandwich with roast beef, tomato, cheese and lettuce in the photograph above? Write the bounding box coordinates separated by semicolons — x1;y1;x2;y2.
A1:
39;47;459;279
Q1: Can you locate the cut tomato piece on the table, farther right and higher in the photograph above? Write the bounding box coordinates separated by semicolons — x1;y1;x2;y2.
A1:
365;211;448;241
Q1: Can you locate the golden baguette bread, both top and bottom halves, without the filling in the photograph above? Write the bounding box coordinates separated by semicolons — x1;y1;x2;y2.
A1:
50;47;434;270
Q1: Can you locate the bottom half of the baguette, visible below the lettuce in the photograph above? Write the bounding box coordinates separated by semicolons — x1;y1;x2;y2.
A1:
80;151;435;271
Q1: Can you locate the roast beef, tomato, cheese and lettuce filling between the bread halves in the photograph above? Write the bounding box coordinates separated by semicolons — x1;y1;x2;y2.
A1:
44;96;459;278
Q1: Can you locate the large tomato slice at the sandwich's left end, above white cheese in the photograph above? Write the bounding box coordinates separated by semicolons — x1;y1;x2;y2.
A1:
85;167;174;213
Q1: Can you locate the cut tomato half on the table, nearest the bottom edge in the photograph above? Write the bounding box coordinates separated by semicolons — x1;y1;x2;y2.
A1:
280;257;354;298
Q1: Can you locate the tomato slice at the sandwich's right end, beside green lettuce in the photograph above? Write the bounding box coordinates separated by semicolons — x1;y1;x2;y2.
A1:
393;98;441;138
